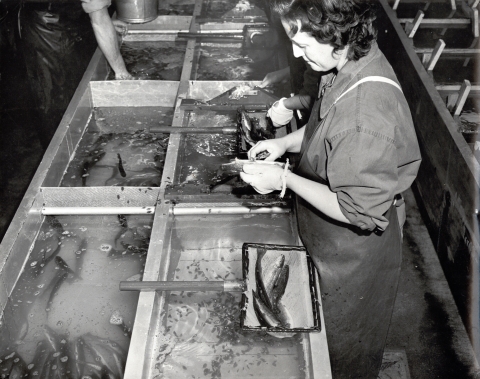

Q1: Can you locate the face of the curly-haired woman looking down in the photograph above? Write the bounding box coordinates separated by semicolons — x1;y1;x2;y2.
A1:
282;20;347;71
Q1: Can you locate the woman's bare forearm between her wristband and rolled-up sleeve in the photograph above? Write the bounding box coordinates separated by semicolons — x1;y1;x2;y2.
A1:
287;173;350;224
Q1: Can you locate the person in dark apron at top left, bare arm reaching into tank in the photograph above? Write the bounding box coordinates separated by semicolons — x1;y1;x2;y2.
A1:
19;0;132;149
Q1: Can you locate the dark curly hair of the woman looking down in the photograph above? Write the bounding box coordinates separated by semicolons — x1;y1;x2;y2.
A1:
269;0;377;61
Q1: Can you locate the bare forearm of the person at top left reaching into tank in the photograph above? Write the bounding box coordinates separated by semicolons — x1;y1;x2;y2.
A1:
89;8;130;79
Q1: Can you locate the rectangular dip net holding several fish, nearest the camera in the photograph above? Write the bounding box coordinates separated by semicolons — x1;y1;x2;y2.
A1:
241;243;321;332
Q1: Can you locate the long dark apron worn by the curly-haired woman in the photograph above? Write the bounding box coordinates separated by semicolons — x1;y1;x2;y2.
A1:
295;81;402;379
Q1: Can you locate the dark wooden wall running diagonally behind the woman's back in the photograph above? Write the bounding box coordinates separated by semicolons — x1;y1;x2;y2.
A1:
378;0;480;357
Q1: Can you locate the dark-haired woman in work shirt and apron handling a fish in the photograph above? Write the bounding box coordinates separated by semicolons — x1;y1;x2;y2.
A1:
241;0;421;379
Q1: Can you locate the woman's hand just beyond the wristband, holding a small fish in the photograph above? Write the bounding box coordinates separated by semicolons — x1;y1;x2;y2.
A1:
240;161;284;195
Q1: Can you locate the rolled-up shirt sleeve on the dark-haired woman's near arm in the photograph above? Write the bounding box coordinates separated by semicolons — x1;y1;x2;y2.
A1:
327;127;398;230
